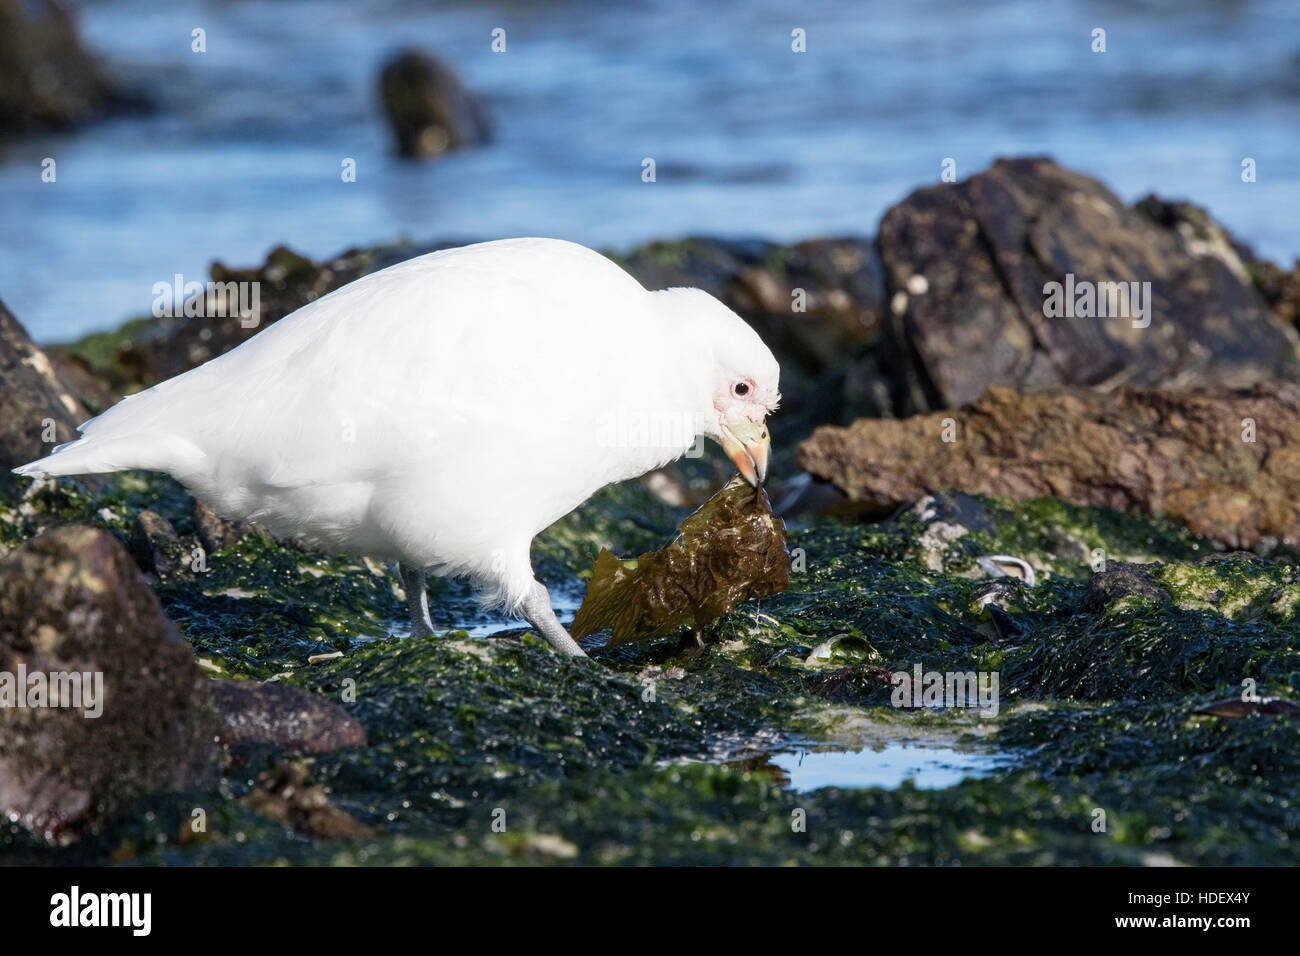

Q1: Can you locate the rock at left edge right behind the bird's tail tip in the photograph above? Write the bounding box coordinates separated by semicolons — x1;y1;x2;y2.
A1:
0;302;90;476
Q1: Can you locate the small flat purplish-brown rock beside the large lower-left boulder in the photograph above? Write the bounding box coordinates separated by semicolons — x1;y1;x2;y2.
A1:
212;680;365;753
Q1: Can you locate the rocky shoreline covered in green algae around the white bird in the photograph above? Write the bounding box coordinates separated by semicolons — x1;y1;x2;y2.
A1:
0;159;1300;864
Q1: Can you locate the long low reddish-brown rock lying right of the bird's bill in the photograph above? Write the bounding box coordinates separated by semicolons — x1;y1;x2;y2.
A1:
798;382;1300;549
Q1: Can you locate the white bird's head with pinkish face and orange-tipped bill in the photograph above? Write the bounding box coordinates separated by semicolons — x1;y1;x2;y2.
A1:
668;289;781;486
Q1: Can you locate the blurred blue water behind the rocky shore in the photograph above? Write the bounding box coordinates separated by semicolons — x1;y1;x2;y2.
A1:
0;0;1300;341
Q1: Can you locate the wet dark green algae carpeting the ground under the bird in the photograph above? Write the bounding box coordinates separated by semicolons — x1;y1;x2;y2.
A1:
0;466;1300;865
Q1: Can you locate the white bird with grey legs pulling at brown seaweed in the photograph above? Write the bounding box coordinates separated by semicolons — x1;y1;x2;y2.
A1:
14;239;780;654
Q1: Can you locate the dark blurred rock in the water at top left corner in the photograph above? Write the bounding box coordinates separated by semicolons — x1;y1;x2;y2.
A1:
0;0;125;133
